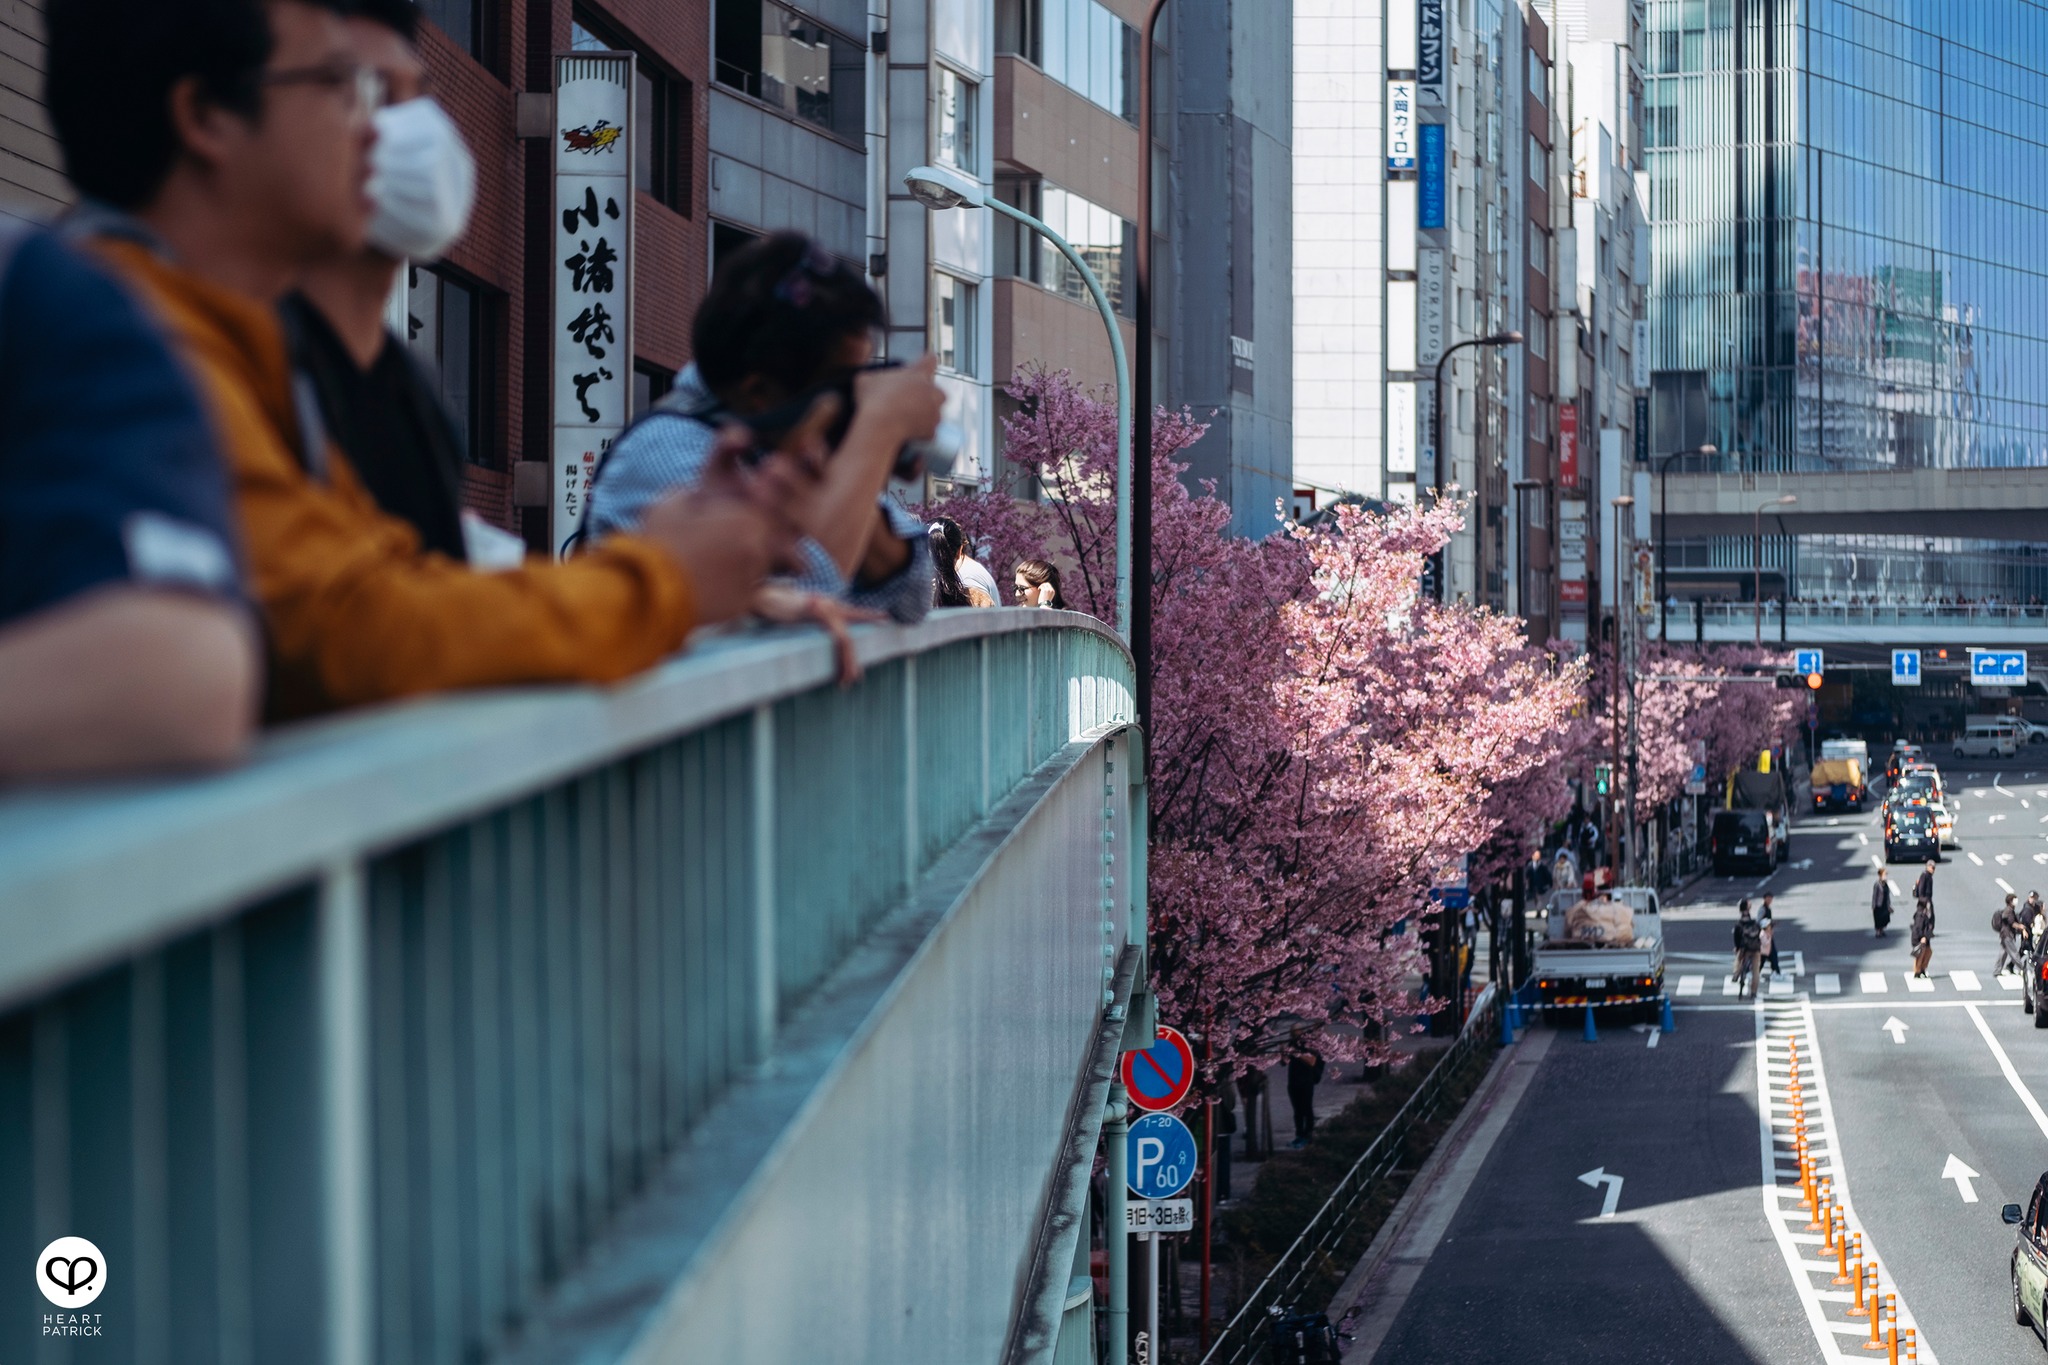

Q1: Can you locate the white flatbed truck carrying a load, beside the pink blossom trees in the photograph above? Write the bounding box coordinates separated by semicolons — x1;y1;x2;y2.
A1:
1530;886;1665;1023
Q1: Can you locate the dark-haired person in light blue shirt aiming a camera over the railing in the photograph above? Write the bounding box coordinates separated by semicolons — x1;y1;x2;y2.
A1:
584;231;946;628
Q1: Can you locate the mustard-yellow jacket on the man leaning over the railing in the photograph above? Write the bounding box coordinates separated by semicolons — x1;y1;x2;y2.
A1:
92;237;696;718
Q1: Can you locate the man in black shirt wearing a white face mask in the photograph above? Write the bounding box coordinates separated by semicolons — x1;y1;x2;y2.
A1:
283;0;491;569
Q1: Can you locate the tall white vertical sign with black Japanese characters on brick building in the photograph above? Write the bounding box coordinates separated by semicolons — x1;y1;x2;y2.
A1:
549;51;633;559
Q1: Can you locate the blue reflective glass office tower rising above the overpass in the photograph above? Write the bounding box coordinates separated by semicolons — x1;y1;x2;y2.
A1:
1645;0;2048;593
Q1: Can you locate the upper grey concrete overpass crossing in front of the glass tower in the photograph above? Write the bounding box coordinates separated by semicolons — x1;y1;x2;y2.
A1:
1651;465;2048;540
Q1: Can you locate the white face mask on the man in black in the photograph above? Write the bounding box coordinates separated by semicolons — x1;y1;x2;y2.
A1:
371;96;477;260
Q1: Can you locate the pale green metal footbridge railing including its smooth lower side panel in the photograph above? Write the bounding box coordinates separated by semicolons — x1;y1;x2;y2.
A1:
0;610;1145;1365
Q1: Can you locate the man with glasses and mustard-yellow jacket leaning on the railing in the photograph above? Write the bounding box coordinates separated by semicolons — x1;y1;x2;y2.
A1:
47;0;815;716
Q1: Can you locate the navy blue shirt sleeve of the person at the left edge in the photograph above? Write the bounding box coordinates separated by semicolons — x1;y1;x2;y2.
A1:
0;231;240;622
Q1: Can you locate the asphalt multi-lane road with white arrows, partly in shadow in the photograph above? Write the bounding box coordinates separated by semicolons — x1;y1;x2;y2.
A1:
1356;747;2048;1365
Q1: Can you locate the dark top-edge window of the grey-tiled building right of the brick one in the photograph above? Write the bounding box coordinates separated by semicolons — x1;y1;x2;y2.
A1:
715;0;868;143
